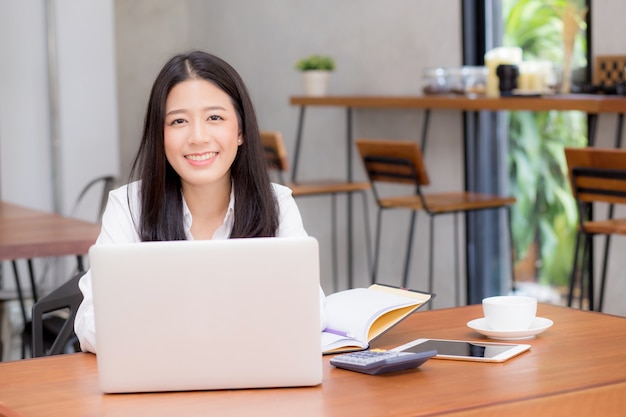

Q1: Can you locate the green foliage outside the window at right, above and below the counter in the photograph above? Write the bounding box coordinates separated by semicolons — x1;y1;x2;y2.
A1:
502;0;587;286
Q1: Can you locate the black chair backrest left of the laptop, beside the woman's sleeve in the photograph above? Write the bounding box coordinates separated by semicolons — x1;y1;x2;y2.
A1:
32;272;84;358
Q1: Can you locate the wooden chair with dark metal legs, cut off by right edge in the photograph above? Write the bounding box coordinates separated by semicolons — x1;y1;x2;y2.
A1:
565;148;626;311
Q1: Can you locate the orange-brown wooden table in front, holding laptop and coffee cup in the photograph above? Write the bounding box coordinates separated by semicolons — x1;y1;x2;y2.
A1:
0;304;626;417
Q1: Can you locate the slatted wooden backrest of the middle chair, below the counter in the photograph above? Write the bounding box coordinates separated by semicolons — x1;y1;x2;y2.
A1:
356;139;430;187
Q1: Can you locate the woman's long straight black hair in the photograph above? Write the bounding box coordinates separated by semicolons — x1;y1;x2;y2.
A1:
130;51;279;241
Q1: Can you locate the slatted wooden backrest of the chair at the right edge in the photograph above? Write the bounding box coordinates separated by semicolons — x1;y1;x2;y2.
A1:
565;148;626;204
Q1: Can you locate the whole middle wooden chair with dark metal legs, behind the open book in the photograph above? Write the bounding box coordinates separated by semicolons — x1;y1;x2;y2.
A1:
356;139;515;305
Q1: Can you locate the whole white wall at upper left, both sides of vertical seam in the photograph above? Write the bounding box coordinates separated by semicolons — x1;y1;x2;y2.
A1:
0;0;119;214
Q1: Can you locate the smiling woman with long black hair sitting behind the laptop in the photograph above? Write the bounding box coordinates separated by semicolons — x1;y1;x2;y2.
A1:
74;51;324;353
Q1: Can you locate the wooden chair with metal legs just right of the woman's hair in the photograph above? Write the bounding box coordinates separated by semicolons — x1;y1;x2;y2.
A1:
261;131;371;290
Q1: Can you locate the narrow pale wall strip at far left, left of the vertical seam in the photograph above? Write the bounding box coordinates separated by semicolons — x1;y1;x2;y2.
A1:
0;1;52;209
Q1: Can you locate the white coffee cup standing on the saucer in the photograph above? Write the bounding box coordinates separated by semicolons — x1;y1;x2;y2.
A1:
483;295;537;331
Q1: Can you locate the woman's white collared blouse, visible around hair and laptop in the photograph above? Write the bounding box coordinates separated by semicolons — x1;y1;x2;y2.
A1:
74;182;326;353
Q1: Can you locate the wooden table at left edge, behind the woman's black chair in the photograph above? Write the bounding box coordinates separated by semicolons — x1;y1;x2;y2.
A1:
0;201;100;332
